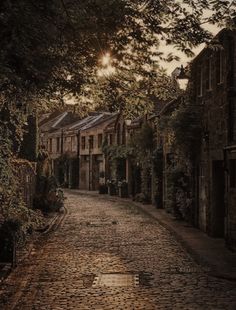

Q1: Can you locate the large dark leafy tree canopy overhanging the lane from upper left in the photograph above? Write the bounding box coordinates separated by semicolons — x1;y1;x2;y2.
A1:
0;0;236;230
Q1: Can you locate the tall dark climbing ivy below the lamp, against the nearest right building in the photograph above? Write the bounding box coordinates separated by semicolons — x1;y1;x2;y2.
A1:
160;96;202;221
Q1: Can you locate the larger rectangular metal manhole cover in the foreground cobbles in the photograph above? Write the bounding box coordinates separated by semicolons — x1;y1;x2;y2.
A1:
93;273;139;287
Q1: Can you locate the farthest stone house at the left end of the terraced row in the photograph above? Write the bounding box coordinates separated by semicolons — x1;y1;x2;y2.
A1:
39;111;80;188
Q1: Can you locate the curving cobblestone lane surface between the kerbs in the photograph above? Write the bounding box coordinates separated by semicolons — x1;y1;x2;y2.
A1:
0;191;236;310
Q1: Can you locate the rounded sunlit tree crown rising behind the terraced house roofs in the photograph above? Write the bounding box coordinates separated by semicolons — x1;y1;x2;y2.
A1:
90;64;180;119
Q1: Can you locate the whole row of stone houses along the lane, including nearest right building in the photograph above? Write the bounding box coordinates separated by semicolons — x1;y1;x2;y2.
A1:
40;29;236;249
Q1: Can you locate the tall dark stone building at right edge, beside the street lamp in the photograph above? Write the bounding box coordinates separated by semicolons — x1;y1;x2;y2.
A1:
190;29;236;248
